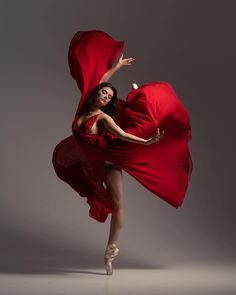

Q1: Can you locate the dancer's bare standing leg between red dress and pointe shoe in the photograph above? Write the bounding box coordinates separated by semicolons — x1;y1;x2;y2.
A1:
105;164;124;244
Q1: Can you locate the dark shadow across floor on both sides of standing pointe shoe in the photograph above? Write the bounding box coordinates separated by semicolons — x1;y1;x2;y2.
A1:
0;253;168;275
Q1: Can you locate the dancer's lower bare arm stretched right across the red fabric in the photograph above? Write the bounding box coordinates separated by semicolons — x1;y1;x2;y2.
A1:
101;114;164;145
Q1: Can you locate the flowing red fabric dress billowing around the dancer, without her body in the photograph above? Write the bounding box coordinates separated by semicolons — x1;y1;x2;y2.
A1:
52;30;193;222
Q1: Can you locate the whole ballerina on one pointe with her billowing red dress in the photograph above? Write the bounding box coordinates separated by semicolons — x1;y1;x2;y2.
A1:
53;30;193;275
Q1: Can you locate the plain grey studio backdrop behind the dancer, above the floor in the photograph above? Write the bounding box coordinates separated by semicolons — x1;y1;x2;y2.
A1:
0;0;236;271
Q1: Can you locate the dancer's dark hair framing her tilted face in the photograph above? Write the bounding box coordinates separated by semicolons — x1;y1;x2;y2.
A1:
81;82;118;118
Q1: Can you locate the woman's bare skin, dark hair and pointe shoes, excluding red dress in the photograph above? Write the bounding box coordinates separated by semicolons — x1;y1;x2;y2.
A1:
77;54;164;274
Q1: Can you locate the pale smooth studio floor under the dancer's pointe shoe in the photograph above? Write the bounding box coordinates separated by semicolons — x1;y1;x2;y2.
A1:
0;264;236;295
